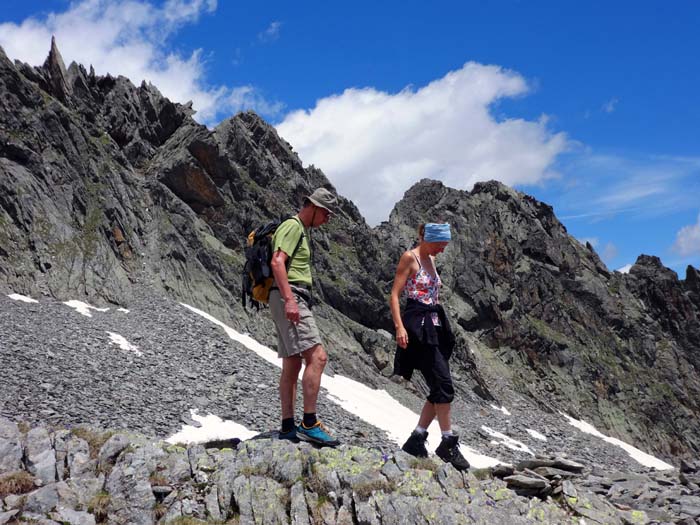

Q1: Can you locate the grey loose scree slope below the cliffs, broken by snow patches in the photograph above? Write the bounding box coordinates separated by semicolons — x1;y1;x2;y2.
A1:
0;292;668;472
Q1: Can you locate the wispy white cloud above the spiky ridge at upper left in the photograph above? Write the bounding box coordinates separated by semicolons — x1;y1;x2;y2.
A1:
0;0;278;123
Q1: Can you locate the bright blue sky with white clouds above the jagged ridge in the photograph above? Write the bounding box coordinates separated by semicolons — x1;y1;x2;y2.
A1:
0;0;700;278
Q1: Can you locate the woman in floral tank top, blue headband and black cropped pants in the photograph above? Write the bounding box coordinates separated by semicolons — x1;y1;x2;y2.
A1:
390;223;469;470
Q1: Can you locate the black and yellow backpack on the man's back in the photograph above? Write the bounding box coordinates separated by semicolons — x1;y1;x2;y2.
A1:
241;217;304;310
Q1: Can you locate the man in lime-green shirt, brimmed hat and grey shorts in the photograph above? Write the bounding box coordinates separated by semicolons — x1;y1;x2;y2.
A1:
269;188;339;446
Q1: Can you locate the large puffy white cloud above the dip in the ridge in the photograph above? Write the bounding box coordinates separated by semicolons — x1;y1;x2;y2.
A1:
278;62;568;224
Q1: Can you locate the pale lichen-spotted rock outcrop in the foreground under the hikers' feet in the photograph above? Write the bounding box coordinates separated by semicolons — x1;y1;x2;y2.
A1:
0;418;700;525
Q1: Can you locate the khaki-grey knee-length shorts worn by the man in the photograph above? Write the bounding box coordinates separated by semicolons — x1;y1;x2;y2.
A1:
269;285;321;357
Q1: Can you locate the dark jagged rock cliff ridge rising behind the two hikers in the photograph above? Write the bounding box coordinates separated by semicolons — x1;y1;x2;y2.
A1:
0;44;700;457
